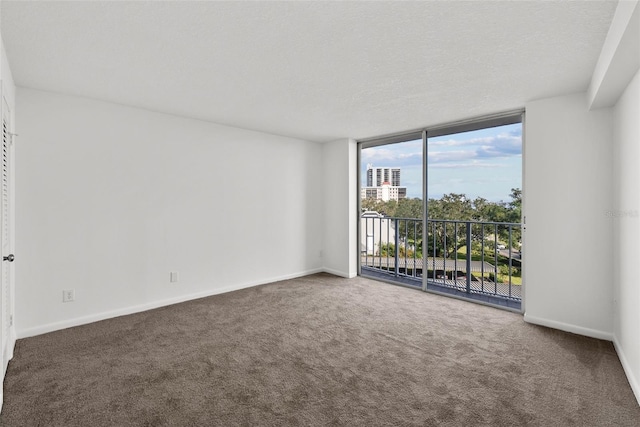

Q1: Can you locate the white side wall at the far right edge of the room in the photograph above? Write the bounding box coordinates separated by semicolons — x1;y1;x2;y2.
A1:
613;71;640;402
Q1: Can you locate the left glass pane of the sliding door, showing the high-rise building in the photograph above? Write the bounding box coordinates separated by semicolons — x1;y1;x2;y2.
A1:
360;139;423;287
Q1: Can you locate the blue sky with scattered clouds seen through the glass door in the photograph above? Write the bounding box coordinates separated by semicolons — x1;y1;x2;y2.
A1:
360;123;522;202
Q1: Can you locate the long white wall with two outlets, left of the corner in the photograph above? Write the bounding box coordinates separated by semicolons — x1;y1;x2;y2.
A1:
16;88;324;337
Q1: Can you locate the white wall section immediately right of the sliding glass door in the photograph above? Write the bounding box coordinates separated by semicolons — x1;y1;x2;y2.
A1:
523;93;613;339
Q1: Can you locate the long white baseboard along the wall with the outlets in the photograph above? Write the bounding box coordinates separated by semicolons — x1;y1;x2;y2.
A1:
14;268;325;342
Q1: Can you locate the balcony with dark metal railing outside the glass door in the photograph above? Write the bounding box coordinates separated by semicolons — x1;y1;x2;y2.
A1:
360;217;522;310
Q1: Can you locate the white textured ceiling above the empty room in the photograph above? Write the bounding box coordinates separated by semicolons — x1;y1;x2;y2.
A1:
1;1;616;141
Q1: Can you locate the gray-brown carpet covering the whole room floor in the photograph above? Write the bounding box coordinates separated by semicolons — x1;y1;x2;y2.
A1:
0;274;640;427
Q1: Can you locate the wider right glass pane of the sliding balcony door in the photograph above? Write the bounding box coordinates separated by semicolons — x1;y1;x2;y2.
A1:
426;123;522;302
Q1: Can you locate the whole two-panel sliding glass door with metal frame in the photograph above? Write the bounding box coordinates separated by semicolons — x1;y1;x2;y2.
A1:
359;112;523;310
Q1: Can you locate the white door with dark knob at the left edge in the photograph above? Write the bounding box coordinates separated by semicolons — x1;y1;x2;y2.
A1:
0;96;14;377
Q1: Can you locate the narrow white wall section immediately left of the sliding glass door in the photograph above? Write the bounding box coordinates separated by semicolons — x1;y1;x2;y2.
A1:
322;139;358;277
